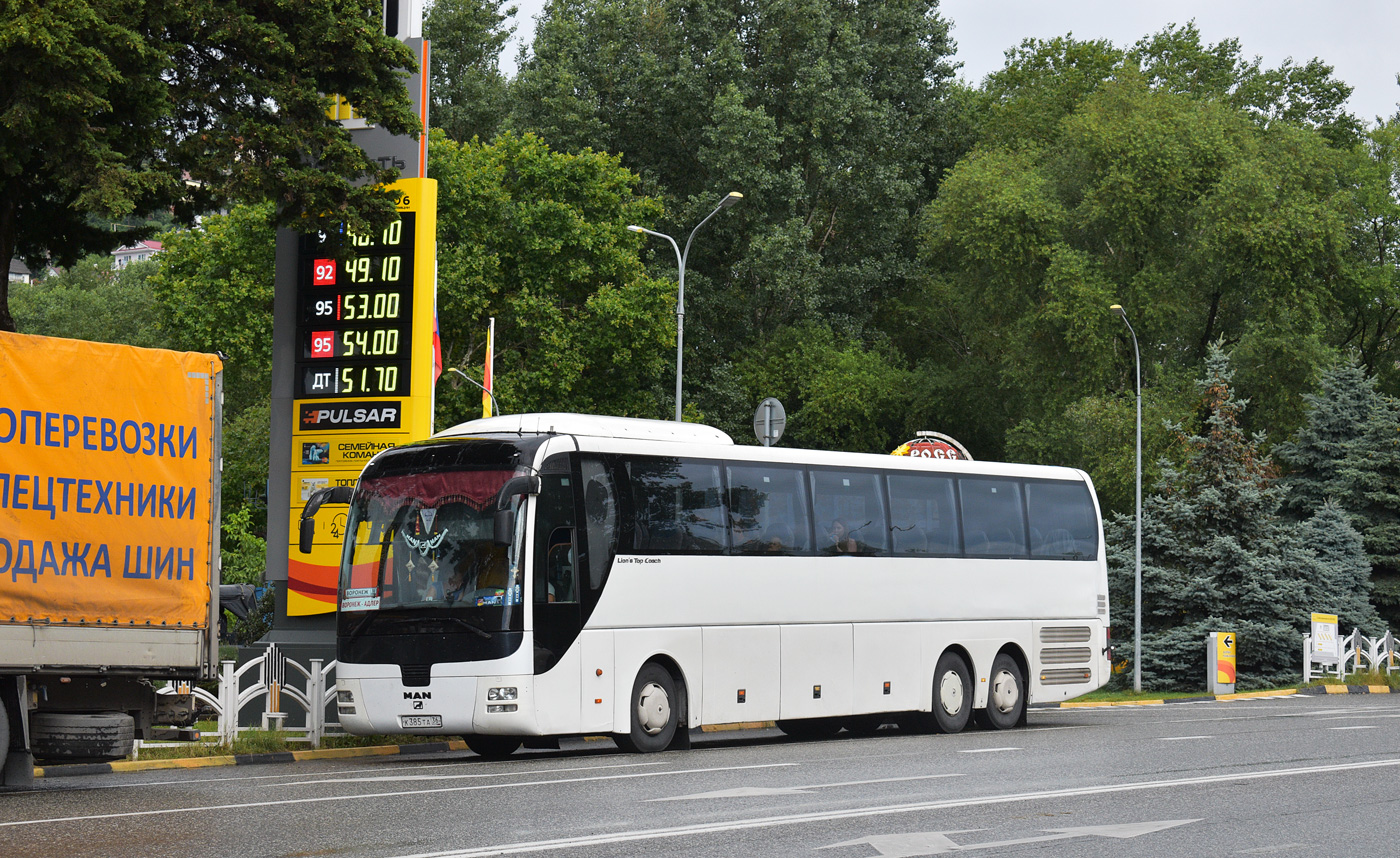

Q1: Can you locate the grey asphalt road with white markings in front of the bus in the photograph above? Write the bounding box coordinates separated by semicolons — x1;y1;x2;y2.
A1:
0;696;1400;858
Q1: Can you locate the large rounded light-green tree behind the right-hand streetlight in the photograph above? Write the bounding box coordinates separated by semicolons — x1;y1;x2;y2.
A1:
912;27;1359;467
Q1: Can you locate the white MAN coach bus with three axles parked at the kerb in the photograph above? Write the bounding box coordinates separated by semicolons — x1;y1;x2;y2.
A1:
302;414;1110;757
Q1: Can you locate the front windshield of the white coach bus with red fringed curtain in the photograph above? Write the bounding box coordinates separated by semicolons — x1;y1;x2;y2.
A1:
340;466;524;621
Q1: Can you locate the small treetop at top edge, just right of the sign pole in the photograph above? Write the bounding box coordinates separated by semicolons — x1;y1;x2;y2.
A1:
423;0;515;143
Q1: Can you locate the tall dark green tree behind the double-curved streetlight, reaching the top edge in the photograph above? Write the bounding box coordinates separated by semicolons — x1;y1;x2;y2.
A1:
508;0;979;428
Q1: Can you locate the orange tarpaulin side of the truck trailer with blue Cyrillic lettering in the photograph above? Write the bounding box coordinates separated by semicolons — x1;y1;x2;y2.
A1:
0;333;223;628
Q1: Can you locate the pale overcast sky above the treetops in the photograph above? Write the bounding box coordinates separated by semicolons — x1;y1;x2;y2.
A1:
501;0;1400;122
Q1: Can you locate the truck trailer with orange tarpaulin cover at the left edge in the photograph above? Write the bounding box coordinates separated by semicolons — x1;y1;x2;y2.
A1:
0;333;223;787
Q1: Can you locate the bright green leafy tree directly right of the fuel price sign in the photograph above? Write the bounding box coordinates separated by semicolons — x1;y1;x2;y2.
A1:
428;132;676;426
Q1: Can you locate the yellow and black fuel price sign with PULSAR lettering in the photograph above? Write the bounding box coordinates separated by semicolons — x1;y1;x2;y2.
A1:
287;179;437;616
